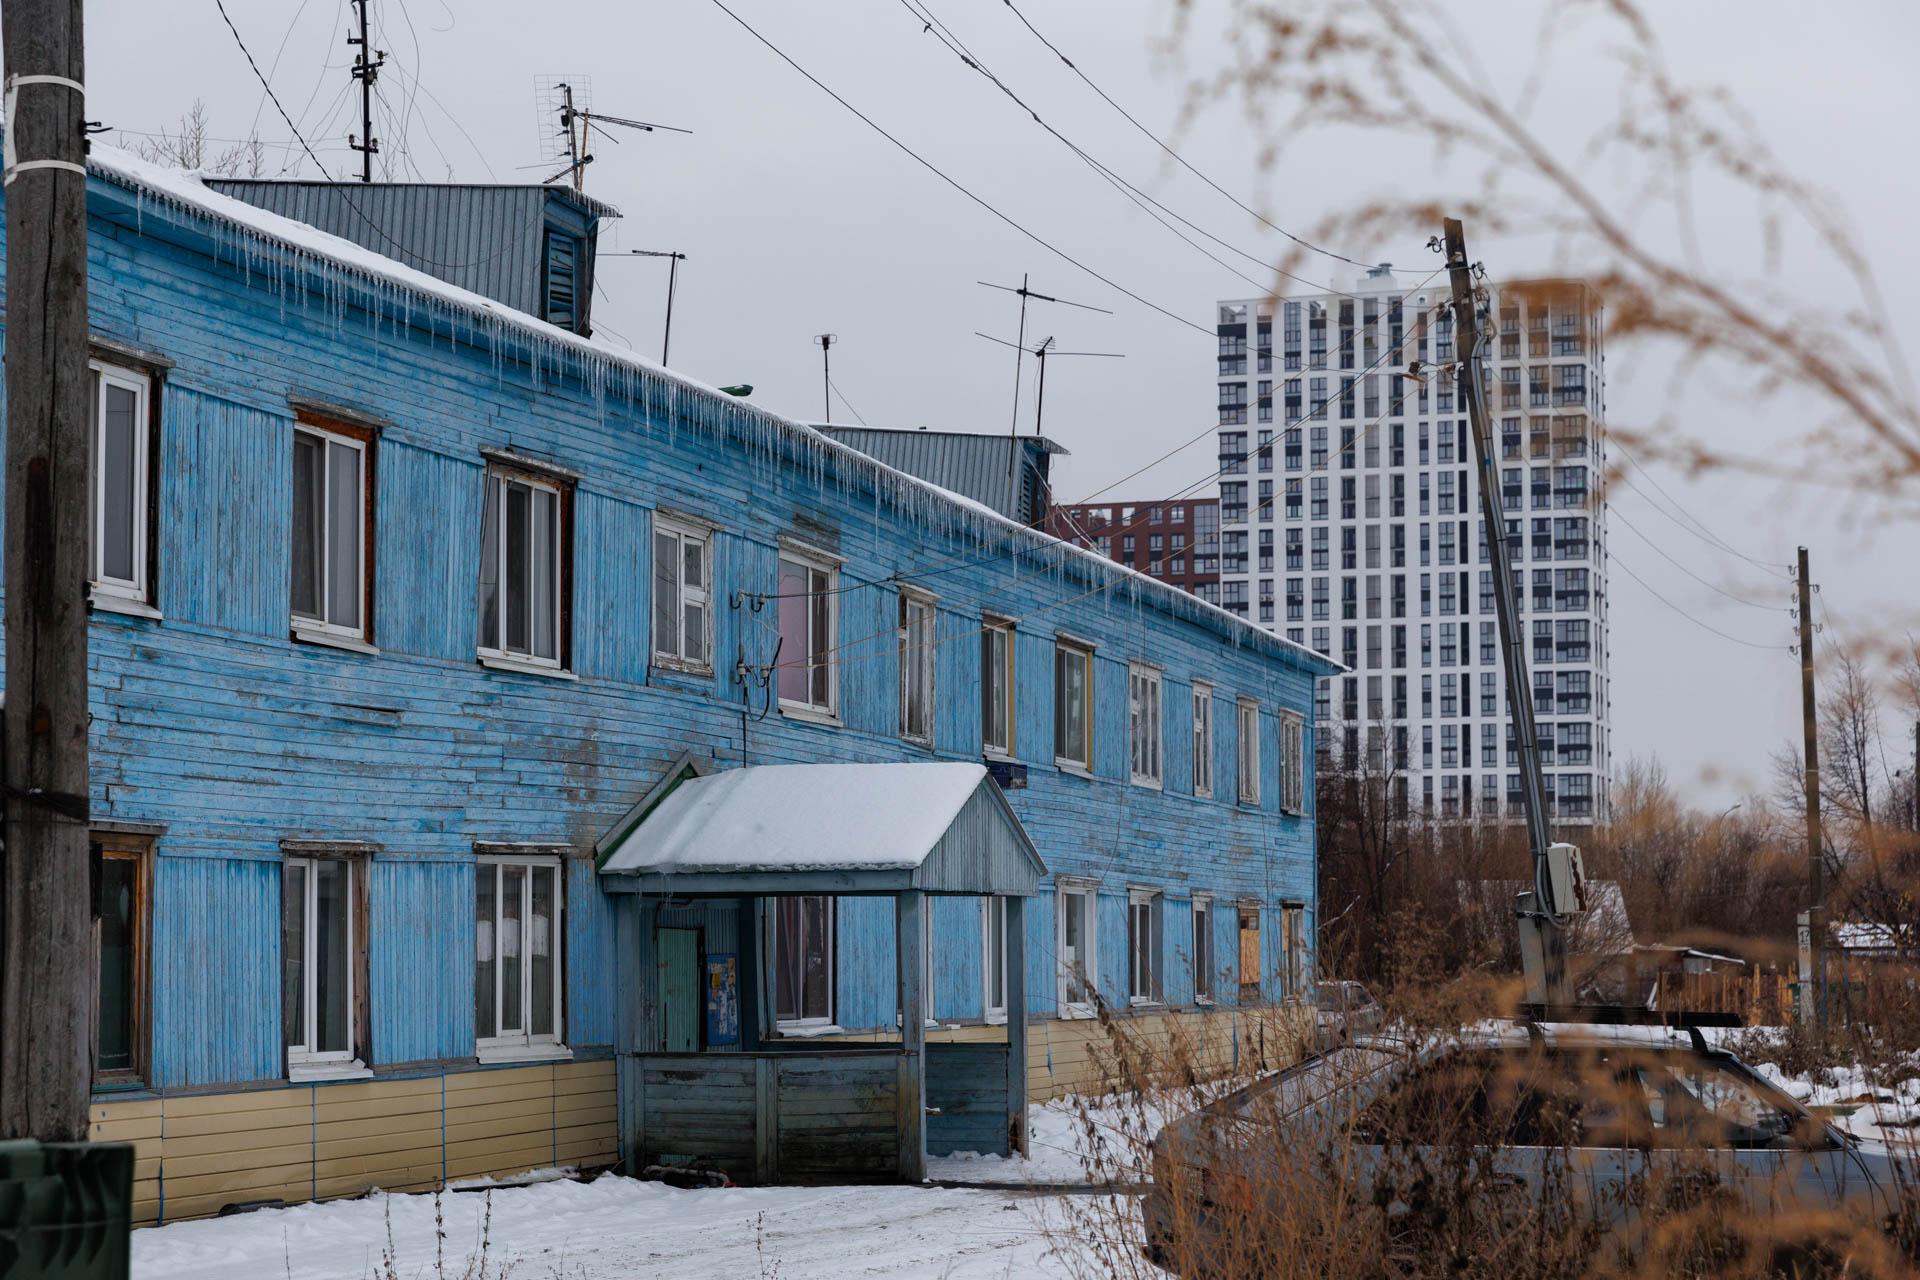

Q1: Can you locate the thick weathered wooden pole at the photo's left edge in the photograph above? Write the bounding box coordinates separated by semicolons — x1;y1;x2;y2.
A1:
0;0;94;1142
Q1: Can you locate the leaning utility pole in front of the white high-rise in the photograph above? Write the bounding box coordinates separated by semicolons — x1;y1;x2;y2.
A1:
1442;219;1571;1006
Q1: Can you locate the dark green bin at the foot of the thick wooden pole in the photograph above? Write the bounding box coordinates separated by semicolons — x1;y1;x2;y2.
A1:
0;1142;132;1280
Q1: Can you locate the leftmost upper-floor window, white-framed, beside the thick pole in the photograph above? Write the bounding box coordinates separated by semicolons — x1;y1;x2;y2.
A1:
88;361;154;604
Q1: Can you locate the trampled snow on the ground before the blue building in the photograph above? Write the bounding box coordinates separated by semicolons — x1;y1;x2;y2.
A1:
132;1174;1113;1280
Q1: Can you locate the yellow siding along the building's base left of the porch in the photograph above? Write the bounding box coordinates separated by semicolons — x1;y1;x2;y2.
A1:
92;1061;618;1224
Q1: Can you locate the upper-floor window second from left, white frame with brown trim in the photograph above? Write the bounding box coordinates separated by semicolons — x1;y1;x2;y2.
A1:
288;420;372;641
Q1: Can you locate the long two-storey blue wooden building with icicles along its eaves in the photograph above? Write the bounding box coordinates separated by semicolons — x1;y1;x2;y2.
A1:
3;148;1334;1221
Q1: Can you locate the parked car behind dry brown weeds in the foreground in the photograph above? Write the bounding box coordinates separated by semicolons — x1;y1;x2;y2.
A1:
1142;1023;1910;1274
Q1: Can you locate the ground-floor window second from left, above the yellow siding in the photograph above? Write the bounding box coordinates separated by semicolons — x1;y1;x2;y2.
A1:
280;842;369;1080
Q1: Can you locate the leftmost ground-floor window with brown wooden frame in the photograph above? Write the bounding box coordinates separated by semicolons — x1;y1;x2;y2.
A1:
92;831;154;1088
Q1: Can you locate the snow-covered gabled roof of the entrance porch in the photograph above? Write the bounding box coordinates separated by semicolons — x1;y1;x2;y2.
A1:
599;762;1046;898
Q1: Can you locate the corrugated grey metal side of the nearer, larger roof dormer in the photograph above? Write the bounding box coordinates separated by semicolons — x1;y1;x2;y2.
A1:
205;178;618;315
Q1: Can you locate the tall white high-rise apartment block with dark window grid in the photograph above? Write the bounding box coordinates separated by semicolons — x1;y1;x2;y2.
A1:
1219;267;1609;825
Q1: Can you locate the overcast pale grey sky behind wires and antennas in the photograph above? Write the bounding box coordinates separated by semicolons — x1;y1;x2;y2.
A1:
74;0;1920;806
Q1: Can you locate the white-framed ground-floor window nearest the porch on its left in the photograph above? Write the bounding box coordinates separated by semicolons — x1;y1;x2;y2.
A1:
474;854;563;1057
